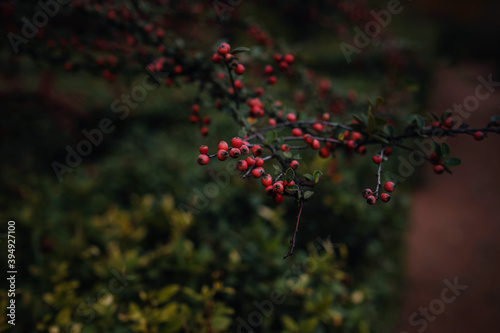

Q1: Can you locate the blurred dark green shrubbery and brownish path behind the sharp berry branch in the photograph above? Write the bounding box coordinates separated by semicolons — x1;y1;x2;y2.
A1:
0;0;500;333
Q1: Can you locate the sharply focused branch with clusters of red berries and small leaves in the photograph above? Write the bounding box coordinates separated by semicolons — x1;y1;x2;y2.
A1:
197;43;500;258
